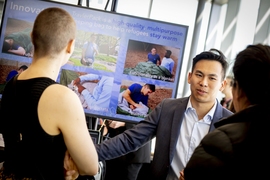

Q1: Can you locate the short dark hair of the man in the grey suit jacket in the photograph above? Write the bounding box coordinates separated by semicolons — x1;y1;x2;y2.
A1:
191;48;228;79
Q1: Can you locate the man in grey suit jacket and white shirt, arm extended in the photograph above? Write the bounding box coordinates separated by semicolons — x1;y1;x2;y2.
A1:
96;49;232;180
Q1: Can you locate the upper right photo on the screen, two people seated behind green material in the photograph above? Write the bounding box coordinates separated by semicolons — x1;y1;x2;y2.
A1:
123;40;180;82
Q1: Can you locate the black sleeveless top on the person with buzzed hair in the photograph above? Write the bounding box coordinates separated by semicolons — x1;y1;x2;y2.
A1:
0;75;66;180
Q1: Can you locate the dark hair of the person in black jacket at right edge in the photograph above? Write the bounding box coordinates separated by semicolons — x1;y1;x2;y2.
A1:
233;44;270;104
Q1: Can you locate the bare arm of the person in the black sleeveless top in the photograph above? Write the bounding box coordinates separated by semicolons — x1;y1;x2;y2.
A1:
38;84;98;175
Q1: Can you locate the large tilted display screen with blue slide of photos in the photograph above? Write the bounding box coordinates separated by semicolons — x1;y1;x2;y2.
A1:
0;0;188;122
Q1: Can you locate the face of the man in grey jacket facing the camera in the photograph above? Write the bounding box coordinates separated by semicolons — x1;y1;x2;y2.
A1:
188;60;225;103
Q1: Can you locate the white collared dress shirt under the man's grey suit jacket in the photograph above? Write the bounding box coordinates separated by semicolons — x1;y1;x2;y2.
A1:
167;99;217;180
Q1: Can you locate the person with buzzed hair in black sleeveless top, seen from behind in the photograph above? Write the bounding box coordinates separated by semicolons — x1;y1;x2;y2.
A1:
0;7;99;180
